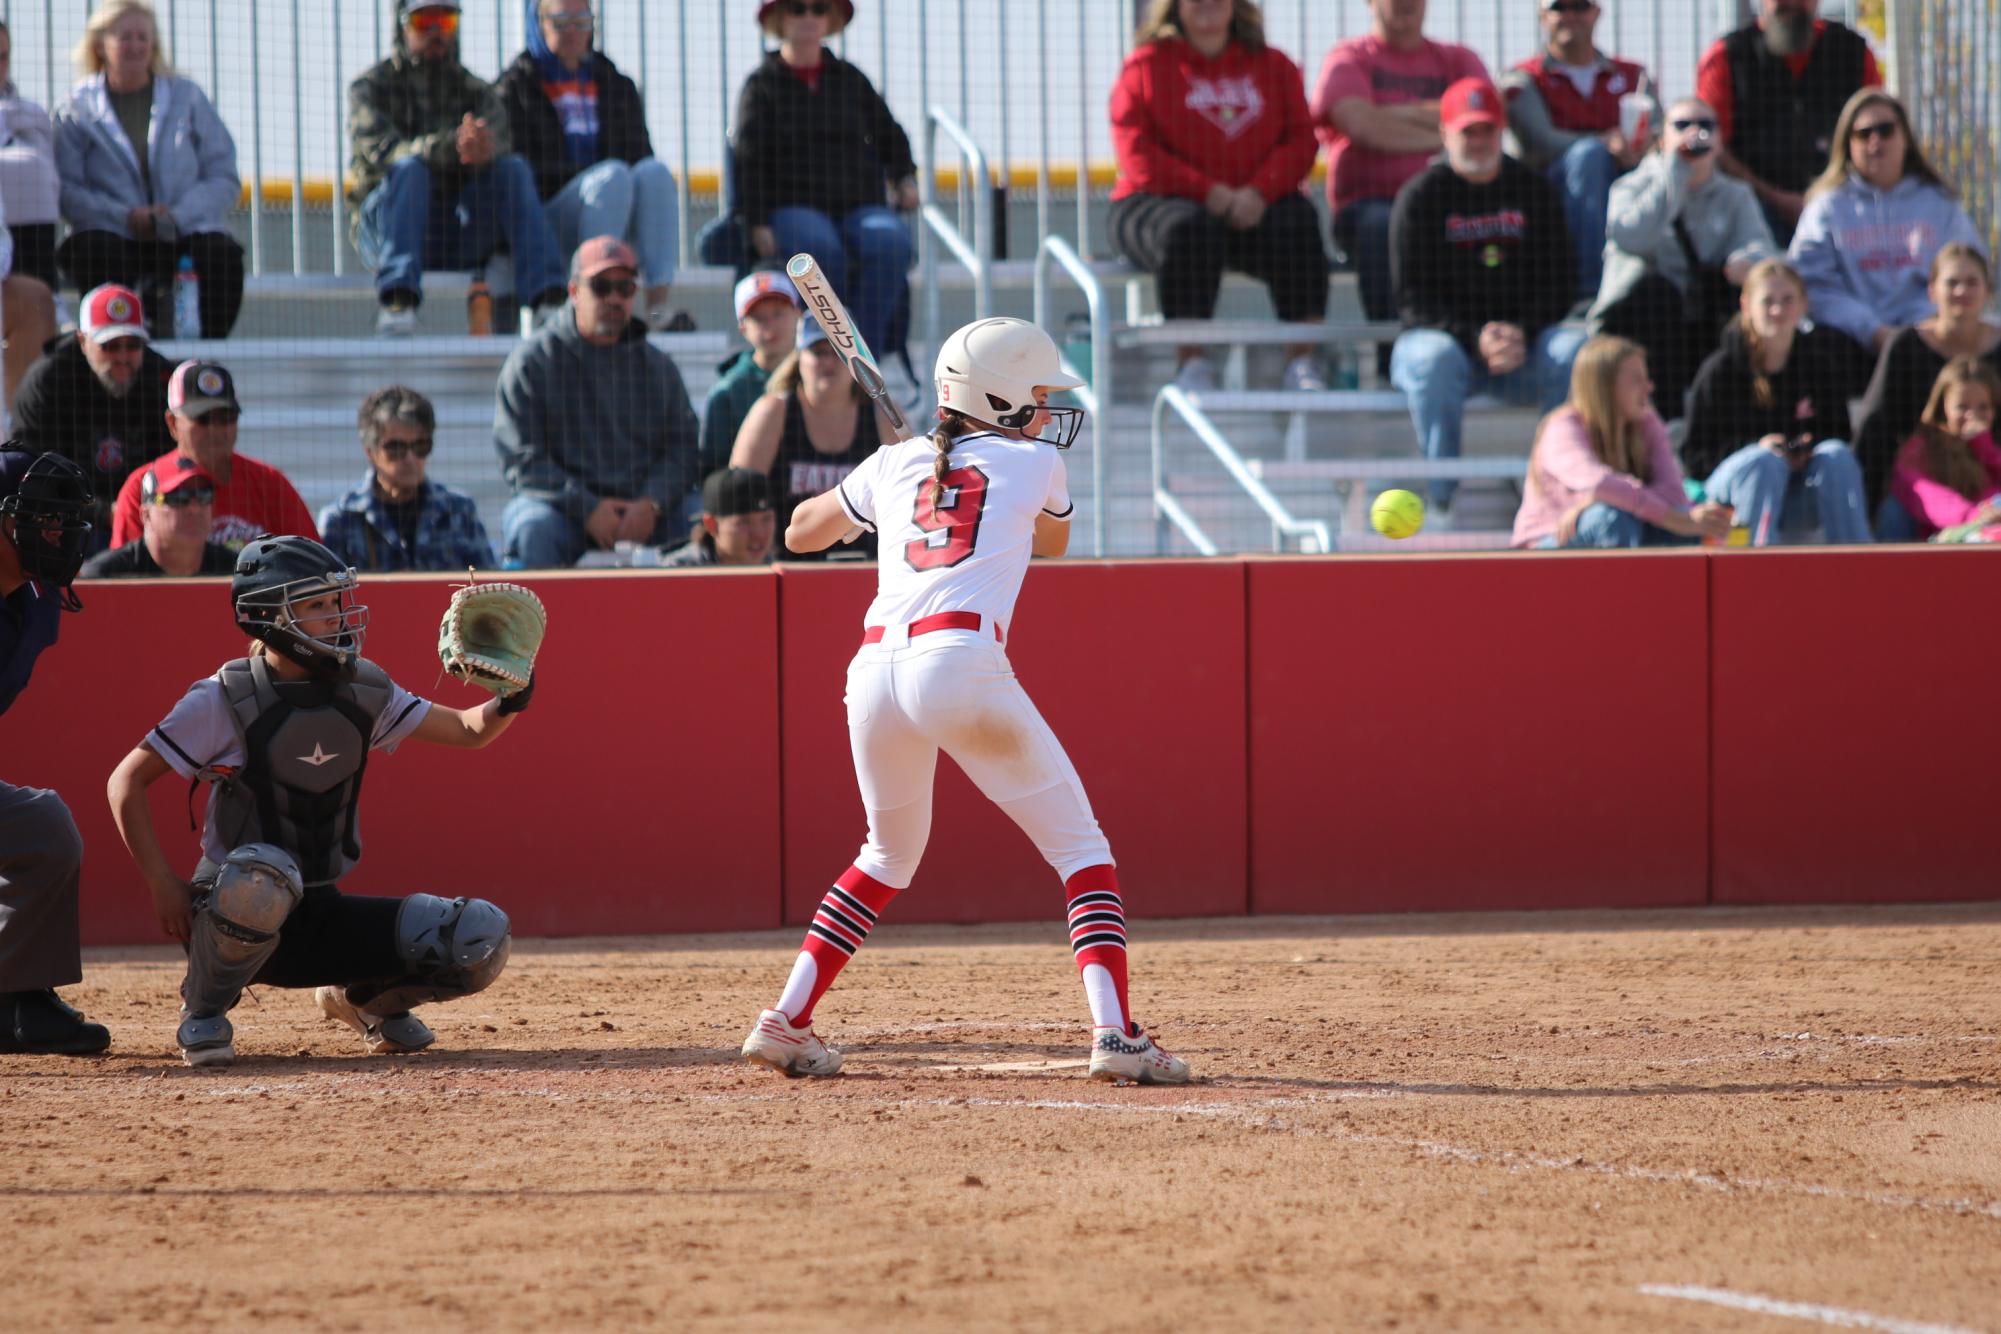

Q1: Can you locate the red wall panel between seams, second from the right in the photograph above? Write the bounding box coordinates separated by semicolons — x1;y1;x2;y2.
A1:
1249;552;1704;912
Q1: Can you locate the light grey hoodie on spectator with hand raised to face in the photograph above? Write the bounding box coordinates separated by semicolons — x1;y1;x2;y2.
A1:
1591;152;1779;320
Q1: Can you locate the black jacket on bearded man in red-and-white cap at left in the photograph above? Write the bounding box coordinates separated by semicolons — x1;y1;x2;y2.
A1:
14;334;174;532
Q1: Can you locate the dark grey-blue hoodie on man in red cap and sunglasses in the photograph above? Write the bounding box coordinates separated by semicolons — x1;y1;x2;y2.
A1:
494;304;700;542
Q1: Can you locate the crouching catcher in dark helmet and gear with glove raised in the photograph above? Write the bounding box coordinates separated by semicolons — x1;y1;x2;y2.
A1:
110;536;544;1066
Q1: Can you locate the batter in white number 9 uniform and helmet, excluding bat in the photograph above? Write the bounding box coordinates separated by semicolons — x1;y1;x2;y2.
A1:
742;318;1189;1084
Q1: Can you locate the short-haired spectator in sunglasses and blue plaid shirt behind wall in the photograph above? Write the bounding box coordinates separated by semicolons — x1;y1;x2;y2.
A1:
320;384;494;570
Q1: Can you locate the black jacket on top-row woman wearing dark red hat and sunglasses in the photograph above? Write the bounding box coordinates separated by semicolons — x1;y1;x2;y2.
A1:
730;52;916;226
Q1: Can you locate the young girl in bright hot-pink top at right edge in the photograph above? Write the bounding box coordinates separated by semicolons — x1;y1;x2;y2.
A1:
1883;356;2001;538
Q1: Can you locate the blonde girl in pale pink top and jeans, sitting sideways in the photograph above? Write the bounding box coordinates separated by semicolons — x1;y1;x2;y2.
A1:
1513;334;1731;548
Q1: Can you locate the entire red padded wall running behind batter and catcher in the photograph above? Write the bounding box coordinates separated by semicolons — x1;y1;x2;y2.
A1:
0;550;2001;944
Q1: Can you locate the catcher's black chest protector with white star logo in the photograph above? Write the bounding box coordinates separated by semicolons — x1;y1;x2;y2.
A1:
210;658;390;884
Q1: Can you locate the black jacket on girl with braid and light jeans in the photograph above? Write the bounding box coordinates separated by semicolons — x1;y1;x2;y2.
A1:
1681;320;1849;482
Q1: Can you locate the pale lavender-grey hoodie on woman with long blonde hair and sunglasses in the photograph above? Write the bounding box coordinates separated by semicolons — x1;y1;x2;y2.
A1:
1791;172;1987;348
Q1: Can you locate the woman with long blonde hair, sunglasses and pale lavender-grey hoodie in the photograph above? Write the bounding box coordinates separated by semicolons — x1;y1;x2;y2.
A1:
1791;88;1985;388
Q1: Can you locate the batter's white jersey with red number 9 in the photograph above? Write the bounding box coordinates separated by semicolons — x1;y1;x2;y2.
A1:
838;432;1073;628
